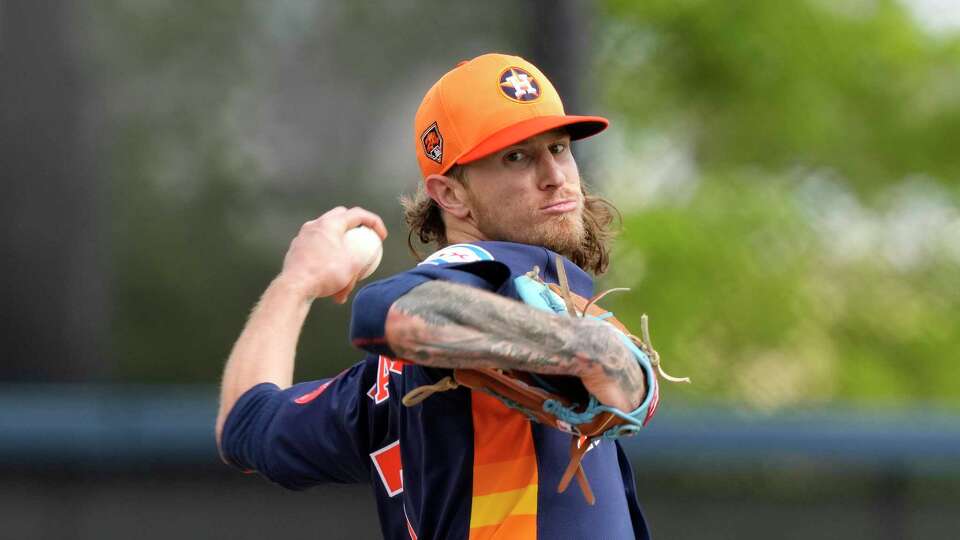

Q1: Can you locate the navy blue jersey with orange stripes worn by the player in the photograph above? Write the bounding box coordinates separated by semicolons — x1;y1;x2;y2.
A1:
222;242;649;540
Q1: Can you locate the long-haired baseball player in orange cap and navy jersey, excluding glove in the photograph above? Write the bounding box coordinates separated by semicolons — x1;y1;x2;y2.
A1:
218;54;656;540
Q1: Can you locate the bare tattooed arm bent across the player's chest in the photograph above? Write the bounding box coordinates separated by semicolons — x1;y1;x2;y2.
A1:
386;281;646;410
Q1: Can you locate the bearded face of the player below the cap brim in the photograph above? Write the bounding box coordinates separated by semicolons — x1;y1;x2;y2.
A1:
466;130;584;254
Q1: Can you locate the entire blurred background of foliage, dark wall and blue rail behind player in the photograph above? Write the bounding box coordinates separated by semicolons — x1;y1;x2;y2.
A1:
0;0;960;540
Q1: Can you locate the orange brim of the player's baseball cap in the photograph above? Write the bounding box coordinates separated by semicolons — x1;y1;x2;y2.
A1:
454;116;610;165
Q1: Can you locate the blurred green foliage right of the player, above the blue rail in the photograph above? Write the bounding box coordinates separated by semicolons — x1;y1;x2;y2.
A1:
598;0;960;410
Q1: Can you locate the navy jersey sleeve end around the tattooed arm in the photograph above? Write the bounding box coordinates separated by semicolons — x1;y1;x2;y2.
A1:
350;261;510;358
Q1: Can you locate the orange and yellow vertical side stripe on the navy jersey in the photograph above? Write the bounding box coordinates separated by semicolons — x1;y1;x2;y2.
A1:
470;392;539;540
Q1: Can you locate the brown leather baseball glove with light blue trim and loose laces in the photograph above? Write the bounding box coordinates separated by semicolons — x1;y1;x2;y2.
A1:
403;258;690;505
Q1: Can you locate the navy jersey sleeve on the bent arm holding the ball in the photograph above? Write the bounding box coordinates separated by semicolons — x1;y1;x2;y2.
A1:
220;362;370;489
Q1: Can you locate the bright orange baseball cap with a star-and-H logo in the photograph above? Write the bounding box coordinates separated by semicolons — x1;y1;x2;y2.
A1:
413;54;610;178
